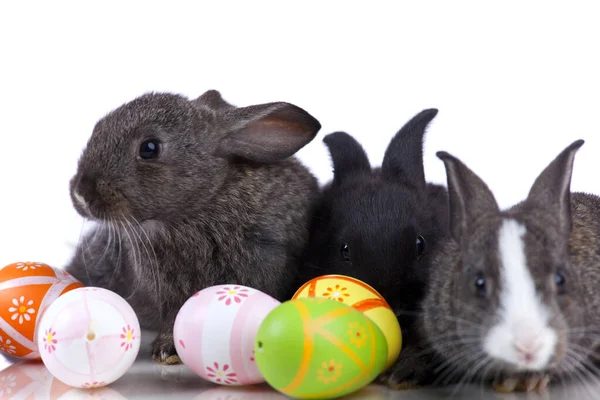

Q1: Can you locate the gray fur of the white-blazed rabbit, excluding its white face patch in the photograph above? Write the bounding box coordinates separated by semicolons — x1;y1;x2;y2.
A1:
386;140;600;390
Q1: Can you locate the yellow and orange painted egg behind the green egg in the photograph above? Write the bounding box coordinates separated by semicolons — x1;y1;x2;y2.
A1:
292;275;402;369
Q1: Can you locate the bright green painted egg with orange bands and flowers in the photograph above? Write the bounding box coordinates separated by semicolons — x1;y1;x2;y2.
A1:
255;298;388;399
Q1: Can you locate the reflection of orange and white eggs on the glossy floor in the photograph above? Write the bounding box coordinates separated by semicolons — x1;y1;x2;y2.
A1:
0;361;126;400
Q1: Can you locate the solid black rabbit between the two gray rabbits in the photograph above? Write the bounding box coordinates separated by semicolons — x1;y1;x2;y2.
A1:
299;109;448;334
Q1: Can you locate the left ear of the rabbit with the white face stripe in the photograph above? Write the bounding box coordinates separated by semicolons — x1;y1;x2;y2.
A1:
437;151;500;245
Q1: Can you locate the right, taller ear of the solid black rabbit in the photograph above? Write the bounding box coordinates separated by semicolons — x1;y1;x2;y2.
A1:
381;108;438;193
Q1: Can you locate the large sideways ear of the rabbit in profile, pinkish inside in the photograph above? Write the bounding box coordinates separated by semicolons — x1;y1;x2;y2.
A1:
215;103;321;163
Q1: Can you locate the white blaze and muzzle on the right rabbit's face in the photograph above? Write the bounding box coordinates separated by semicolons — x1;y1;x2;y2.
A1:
483;219;558;371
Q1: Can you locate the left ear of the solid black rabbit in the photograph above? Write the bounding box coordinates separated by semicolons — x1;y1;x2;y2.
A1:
323;132;371;184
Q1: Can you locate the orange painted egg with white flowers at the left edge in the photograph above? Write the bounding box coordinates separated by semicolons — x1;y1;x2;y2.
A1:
0;262;83;360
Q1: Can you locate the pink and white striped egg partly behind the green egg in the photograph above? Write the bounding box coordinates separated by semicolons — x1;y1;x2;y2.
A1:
173;284;280;385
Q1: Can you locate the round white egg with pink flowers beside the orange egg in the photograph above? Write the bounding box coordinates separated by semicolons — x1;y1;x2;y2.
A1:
37;287;140;389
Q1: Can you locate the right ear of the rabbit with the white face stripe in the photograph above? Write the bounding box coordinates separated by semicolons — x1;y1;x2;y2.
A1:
527;139;584;235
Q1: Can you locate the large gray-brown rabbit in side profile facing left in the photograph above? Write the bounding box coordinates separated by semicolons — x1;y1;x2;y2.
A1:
66;90;321;364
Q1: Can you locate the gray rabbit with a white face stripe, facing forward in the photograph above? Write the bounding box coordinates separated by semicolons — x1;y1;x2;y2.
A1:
382;140;600;391
